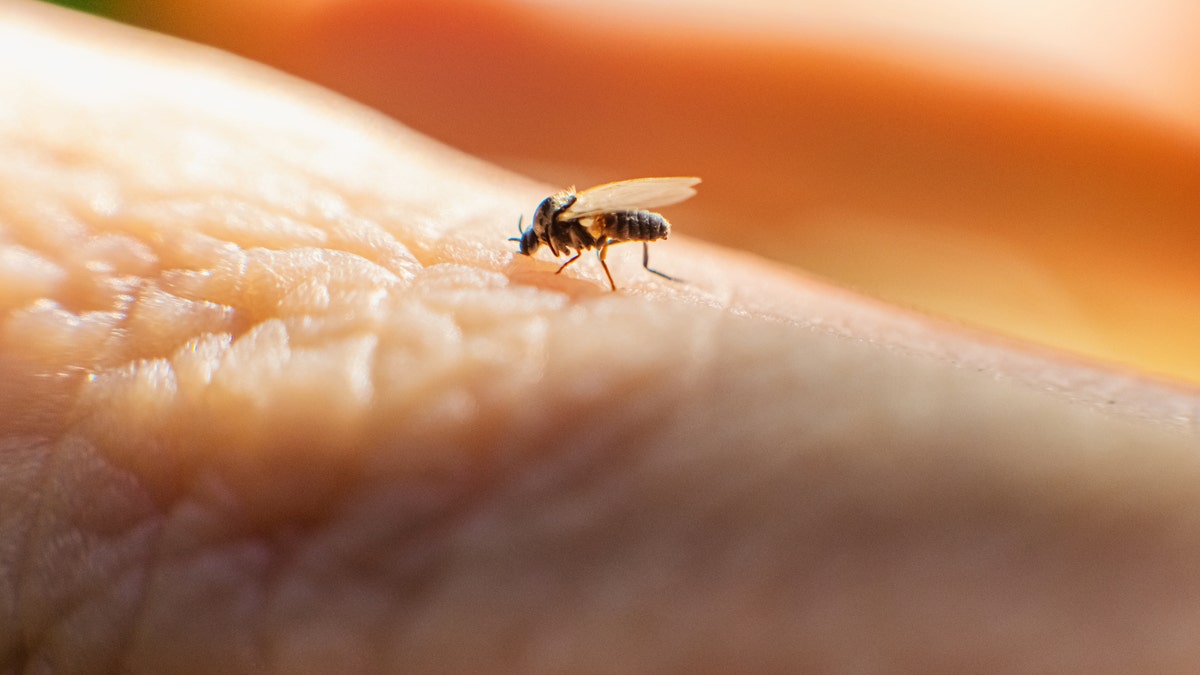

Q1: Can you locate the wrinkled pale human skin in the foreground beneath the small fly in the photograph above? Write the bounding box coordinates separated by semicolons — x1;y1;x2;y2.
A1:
7;4;1200;673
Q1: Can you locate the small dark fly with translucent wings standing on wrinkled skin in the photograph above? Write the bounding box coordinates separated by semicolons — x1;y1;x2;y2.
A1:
509;177;700;291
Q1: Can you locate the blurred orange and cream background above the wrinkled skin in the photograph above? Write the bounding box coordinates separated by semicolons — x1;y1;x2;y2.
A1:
35;0;1200;386
